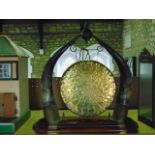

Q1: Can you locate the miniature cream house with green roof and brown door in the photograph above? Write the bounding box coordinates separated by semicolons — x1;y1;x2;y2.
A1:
0;35;32;133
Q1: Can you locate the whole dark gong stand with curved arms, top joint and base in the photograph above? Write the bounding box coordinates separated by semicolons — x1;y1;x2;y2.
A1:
34;21;138;134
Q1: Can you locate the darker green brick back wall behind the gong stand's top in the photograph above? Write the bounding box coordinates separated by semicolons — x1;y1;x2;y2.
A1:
0;21;123;78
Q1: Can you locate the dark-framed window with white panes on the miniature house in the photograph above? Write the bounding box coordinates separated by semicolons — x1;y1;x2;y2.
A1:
0;62;17;80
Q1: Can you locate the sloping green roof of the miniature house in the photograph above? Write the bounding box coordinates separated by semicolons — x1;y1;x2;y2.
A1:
0;35;31;57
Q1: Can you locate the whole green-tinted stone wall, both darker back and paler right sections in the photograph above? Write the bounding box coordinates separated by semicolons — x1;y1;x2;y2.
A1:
3;19;155;78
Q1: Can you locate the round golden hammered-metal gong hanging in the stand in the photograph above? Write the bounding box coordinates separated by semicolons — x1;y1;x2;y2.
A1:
60;60;116;117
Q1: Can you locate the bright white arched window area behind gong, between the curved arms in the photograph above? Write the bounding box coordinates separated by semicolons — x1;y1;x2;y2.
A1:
53;44;114;77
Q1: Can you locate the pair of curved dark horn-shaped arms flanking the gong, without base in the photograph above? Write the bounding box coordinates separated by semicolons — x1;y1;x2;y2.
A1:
42;35;132;126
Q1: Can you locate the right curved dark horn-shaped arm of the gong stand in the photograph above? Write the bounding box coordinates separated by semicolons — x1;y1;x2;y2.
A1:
93;36;132;122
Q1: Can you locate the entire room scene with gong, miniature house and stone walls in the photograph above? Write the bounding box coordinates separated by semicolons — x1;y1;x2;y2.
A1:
0;19;155;135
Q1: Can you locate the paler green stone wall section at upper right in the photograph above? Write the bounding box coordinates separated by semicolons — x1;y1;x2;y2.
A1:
123;19;155;57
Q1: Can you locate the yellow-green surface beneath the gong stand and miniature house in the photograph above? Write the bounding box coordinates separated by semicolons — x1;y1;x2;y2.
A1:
15;110;155;135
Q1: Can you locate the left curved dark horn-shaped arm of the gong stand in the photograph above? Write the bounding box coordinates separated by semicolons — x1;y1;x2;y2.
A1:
41;36;79;125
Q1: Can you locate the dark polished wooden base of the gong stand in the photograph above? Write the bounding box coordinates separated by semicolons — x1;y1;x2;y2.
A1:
33;118;138;134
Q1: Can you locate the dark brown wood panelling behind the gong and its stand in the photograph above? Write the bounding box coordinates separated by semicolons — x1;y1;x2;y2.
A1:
29;77;139;109
